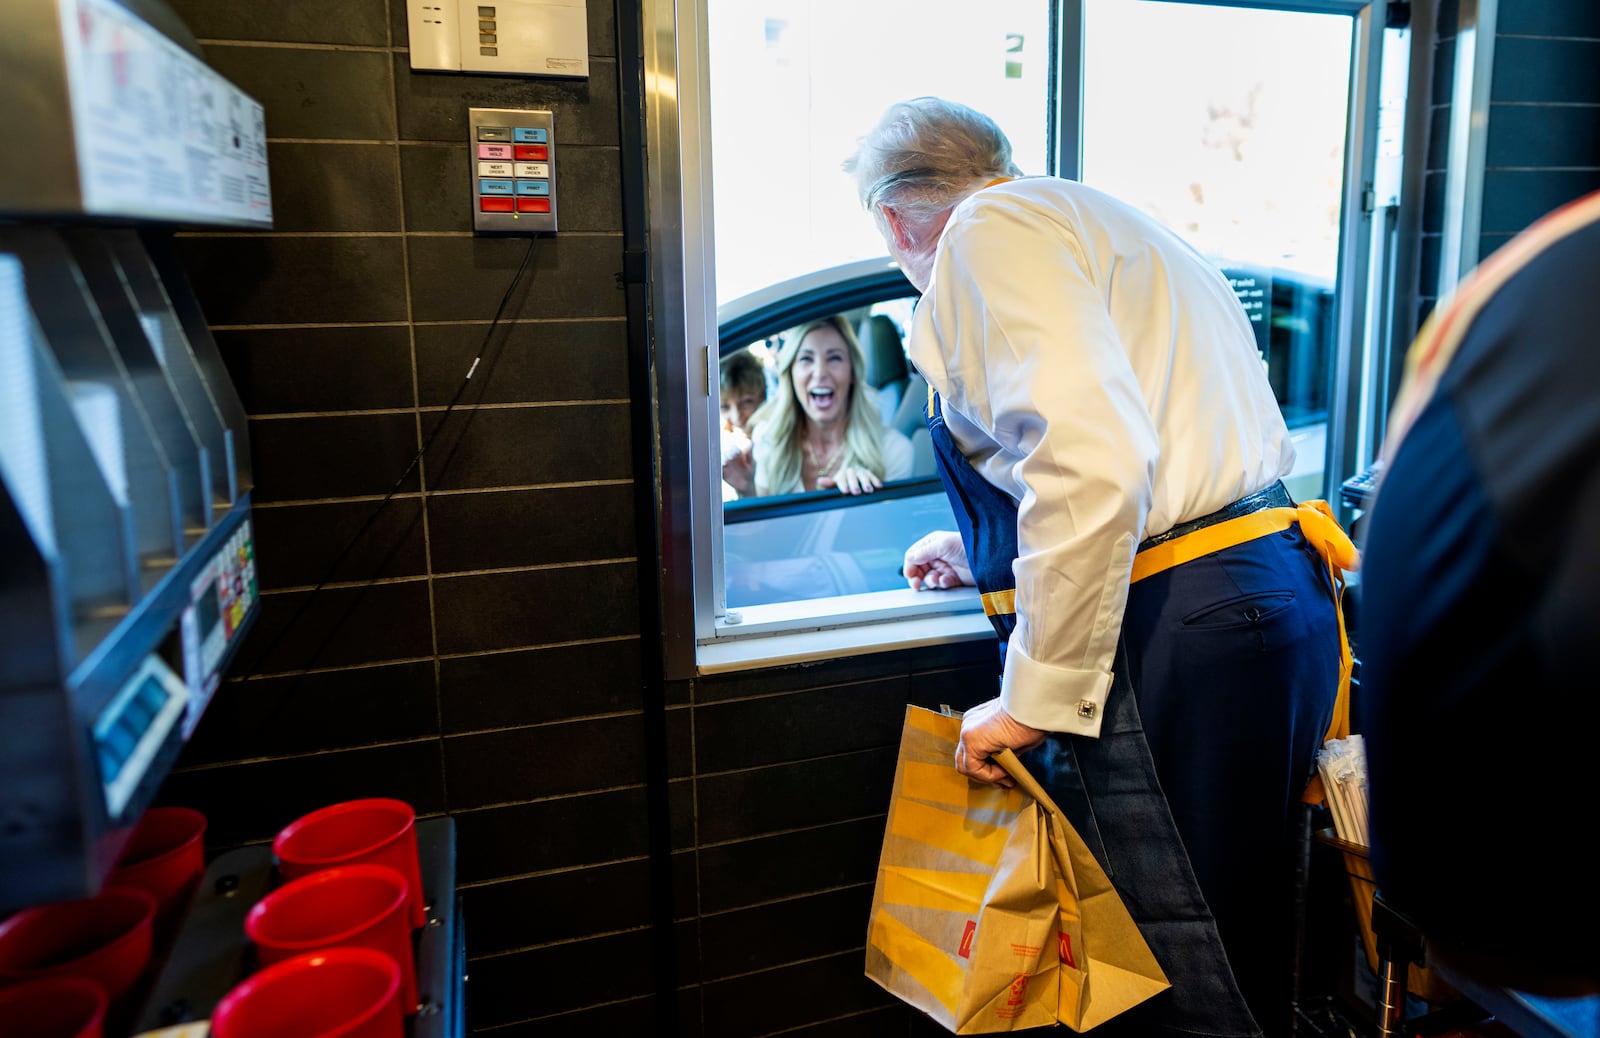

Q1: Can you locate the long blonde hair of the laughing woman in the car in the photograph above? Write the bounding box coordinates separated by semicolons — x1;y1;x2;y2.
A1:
750;313;883;494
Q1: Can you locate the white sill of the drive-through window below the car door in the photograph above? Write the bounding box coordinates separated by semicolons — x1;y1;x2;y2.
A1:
696;587;995;675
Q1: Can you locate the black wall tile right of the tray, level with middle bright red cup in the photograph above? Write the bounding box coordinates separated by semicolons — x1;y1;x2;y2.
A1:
461;859;650;956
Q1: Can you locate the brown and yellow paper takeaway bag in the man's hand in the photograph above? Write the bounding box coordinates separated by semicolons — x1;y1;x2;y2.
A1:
867;707;1168;1035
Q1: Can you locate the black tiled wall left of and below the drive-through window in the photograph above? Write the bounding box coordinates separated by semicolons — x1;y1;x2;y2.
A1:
150;0;995;1038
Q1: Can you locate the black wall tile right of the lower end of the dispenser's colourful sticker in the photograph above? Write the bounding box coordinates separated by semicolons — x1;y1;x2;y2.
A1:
232;581;430;678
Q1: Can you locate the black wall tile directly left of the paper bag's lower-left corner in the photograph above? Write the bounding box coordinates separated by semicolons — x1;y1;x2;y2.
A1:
701;883;872;980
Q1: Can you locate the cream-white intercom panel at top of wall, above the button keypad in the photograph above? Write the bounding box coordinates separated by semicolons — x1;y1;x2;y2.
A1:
406;0;589;78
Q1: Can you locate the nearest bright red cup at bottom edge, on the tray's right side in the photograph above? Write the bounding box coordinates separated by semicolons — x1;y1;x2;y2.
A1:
211;948;405;1038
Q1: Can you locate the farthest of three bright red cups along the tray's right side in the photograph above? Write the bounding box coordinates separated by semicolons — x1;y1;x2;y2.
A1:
272;798;427;926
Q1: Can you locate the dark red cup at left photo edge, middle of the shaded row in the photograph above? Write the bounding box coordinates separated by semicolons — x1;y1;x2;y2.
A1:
0;888;155;1008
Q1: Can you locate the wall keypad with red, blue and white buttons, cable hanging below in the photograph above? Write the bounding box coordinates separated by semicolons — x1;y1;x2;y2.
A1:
467;109;555;234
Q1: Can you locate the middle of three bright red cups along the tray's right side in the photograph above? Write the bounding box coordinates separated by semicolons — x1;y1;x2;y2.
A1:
245;865;418;1016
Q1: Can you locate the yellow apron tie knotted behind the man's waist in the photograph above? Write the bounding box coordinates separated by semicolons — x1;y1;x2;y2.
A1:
1131;501;1362;804
